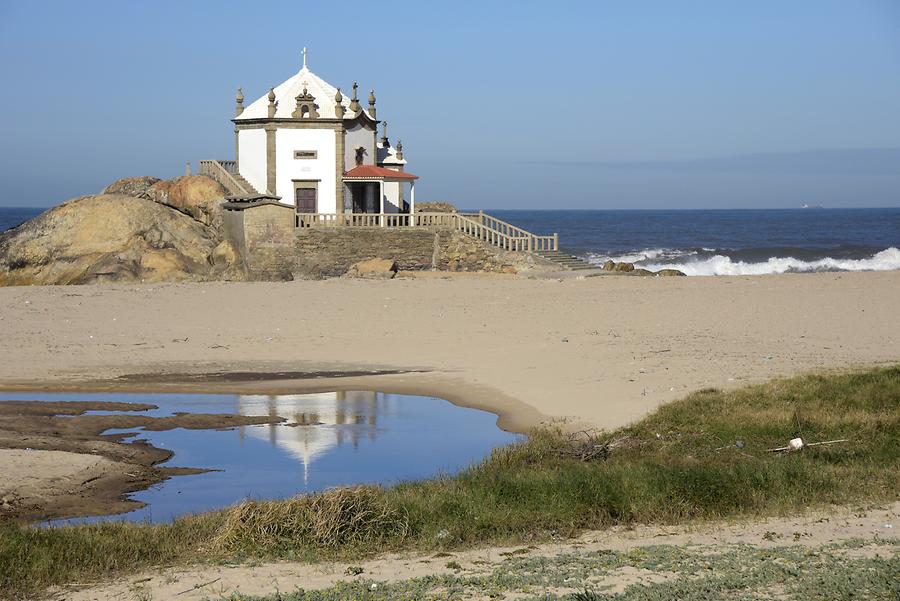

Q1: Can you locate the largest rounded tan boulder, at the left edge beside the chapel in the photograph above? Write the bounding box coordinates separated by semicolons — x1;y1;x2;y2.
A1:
0;194;227;285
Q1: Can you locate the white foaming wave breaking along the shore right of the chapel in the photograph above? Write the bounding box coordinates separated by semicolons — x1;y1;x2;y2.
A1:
640;247;900;275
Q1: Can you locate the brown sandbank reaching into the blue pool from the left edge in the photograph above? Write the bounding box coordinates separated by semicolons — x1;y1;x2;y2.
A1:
0;401;284;523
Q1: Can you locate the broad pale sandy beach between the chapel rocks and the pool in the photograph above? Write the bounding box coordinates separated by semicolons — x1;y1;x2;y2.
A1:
0;272;900;514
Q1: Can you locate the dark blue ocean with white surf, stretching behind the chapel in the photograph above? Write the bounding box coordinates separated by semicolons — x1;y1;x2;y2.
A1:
0;208;900;275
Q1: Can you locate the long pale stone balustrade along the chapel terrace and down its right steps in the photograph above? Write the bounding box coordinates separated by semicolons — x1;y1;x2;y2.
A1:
294;213;559;252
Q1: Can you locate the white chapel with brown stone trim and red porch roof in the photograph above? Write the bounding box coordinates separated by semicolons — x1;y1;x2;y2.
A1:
214;48;418;215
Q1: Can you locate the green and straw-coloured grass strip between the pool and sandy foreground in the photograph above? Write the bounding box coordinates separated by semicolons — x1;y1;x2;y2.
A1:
0;367;900;598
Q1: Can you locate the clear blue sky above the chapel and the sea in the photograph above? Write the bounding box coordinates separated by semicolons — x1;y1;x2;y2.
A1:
0;0;900;209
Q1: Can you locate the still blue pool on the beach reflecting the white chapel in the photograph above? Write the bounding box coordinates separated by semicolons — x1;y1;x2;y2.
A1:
0;391;520;522
